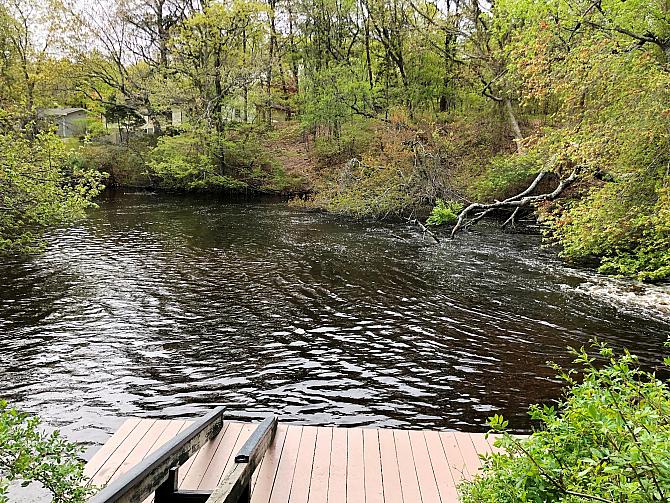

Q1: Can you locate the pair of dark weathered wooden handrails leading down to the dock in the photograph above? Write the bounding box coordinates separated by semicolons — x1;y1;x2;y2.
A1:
88;407;277;503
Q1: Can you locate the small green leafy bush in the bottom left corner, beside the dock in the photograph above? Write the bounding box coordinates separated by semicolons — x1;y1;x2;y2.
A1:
0;400;92;503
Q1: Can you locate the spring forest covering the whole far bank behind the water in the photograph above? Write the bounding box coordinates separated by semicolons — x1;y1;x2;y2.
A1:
0;0;670;281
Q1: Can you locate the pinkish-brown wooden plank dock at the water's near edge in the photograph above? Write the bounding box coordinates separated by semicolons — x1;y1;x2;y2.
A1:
86;419;492;503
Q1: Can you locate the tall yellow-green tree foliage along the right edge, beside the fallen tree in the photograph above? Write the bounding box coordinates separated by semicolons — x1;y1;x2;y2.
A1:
486;0;670;281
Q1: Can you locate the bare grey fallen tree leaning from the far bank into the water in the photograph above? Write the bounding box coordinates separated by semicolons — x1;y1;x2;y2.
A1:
450;168;579;238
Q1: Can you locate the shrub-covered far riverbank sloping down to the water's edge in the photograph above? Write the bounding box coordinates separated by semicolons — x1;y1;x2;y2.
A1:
77;113;670;288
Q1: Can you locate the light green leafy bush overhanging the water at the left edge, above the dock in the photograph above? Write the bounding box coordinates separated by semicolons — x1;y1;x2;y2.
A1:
0;133;103;251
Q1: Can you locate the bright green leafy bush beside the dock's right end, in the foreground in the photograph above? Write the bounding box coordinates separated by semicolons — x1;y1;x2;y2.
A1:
459;345;670;503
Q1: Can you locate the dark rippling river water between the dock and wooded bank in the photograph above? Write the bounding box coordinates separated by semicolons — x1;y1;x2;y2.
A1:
0;194;670;452
